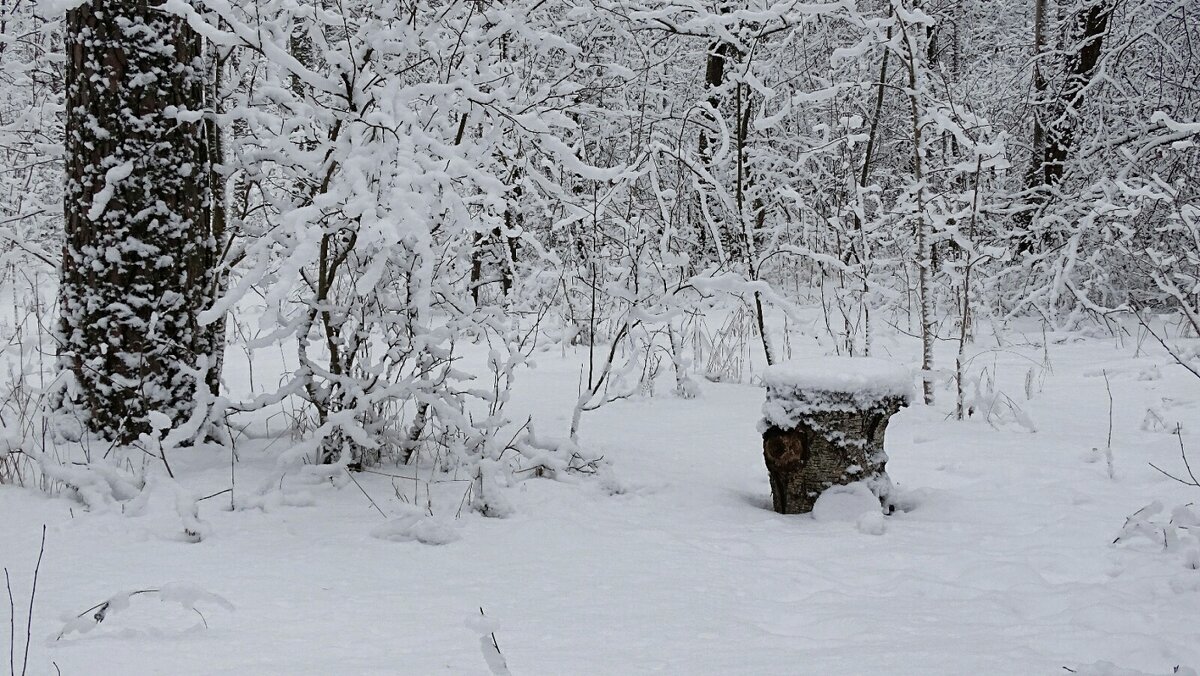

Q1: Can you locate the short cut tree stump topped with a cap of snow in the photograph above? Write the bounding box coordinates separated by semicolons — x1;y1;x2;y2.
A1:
758;357;912;514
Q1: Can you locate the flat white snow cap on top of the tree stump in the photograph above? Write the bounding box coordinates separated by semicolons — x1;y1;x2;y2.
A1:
762;357;913;401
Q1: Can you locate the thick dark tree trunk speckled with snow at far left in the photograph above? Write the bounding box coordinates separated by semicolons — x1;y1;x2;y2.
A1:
60;0;215;443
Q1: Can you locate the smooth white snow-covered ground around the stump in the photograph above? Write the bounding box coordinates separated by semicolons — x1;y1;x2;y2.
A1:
0;329;1200;676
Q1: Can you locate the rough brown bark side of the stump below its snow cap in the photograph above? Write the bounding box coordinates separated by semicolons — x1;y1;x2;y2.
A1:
762;391;905;514
